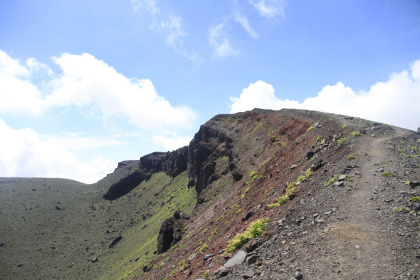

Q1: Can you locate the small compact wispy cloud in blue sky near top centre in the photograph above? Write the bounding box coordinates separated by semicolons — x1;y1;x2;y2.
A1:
209;23;238;57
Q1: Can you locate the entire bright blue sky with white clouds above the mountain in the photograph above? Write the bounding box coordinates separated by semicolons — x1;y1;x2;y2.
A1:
0;0;420;183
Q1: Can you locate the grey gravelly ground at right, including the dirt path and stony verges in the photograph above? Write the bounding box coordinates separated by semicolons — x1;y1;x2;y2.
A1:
221;129;420;280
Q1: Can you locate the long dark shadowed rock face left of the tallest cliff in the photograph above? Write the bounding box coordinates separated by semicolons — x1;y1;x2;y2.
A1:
103;147;188;200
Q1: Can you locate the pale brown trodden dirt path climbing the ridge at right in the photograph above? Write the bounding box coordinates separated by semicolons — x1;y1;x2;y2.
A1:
324;132;401;279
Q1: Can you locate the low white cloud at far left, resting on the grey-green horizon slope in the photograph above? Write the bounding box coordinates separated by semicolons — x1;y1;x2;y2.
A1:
0;119;116;183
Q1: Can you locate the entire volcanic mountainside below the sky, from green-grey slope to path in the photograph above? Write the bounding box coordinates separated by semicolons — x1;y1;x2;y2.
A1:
0;109;420;279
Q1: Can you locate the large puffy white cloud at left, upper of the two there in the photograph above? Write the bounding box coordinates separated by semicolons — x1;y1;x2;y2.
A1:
0;51;195;129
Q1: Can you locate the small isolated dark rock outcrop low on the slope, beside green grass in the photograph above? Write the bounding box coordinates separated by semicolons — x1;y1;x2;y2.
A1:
157;210;189;254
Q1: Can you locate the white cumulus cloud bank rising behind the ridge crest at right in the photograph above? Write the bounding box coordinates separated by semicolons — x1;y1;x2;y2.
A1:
230;60;420;130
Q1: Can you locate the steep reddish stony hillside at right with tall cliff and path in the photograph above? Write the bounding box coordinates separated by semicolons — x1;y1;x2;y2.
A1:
134;110;420;279
